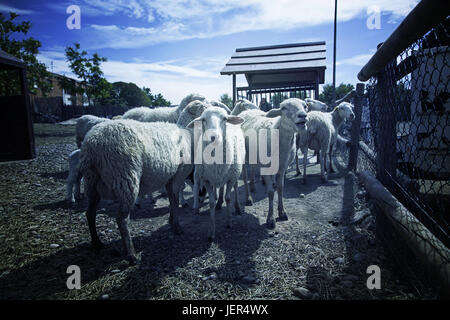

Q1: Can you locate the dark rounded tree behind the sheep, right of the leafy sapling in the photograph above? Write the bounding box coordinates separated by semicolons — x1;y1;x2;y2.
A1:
112;81;152;107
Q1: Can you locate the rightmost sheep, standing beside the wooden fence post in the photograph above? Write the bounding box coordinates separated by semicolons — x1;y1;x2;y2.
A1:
298;102;355;183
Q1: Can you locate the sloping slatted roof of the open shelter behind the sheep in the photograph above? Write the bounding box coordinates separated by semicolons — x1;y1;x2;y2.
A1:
220;41;326;85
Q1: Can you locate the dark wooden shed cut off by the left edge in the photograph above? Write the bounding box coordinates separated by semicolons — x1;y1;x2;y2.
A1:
0;50;36;161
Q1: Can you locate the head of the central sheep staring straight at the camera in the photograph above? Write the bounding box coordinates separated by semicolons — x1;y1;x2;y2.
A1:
187;107;244;143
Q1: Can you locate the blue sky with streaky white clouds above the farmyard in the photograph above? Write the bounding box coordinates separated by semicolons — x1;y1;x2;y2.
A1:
0;0;419;104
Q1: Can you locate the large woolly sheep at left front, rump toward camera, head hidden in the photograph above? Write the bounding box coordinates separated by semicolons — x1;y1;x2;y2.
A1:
80;119;192;264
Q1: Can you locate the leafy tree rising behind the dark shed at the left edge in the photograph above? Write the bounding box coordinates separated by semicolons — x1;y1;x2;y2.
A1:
0;12;52;96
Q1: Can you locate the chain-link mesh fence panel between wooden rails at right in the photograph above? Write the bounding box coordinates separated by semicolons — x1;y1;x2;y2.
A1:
350;17;450;247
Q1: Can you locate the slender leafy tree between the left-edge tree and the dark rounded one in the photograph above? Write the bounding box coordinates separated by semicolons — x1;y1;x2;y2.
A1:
60;43;110;104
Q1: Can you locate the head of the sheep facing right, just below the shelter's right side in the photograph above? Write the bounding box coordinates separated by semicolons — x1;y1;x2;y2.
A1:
266;98;308;132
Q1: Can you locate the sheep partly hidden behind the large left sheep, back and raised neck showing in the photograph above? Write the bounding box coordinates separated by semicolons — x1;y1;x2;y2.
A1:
122;93;205;123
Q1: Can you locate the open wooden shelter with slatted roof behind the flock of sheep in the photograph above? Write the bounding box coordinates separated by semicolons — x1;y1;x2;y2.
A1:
220;41;326;109
